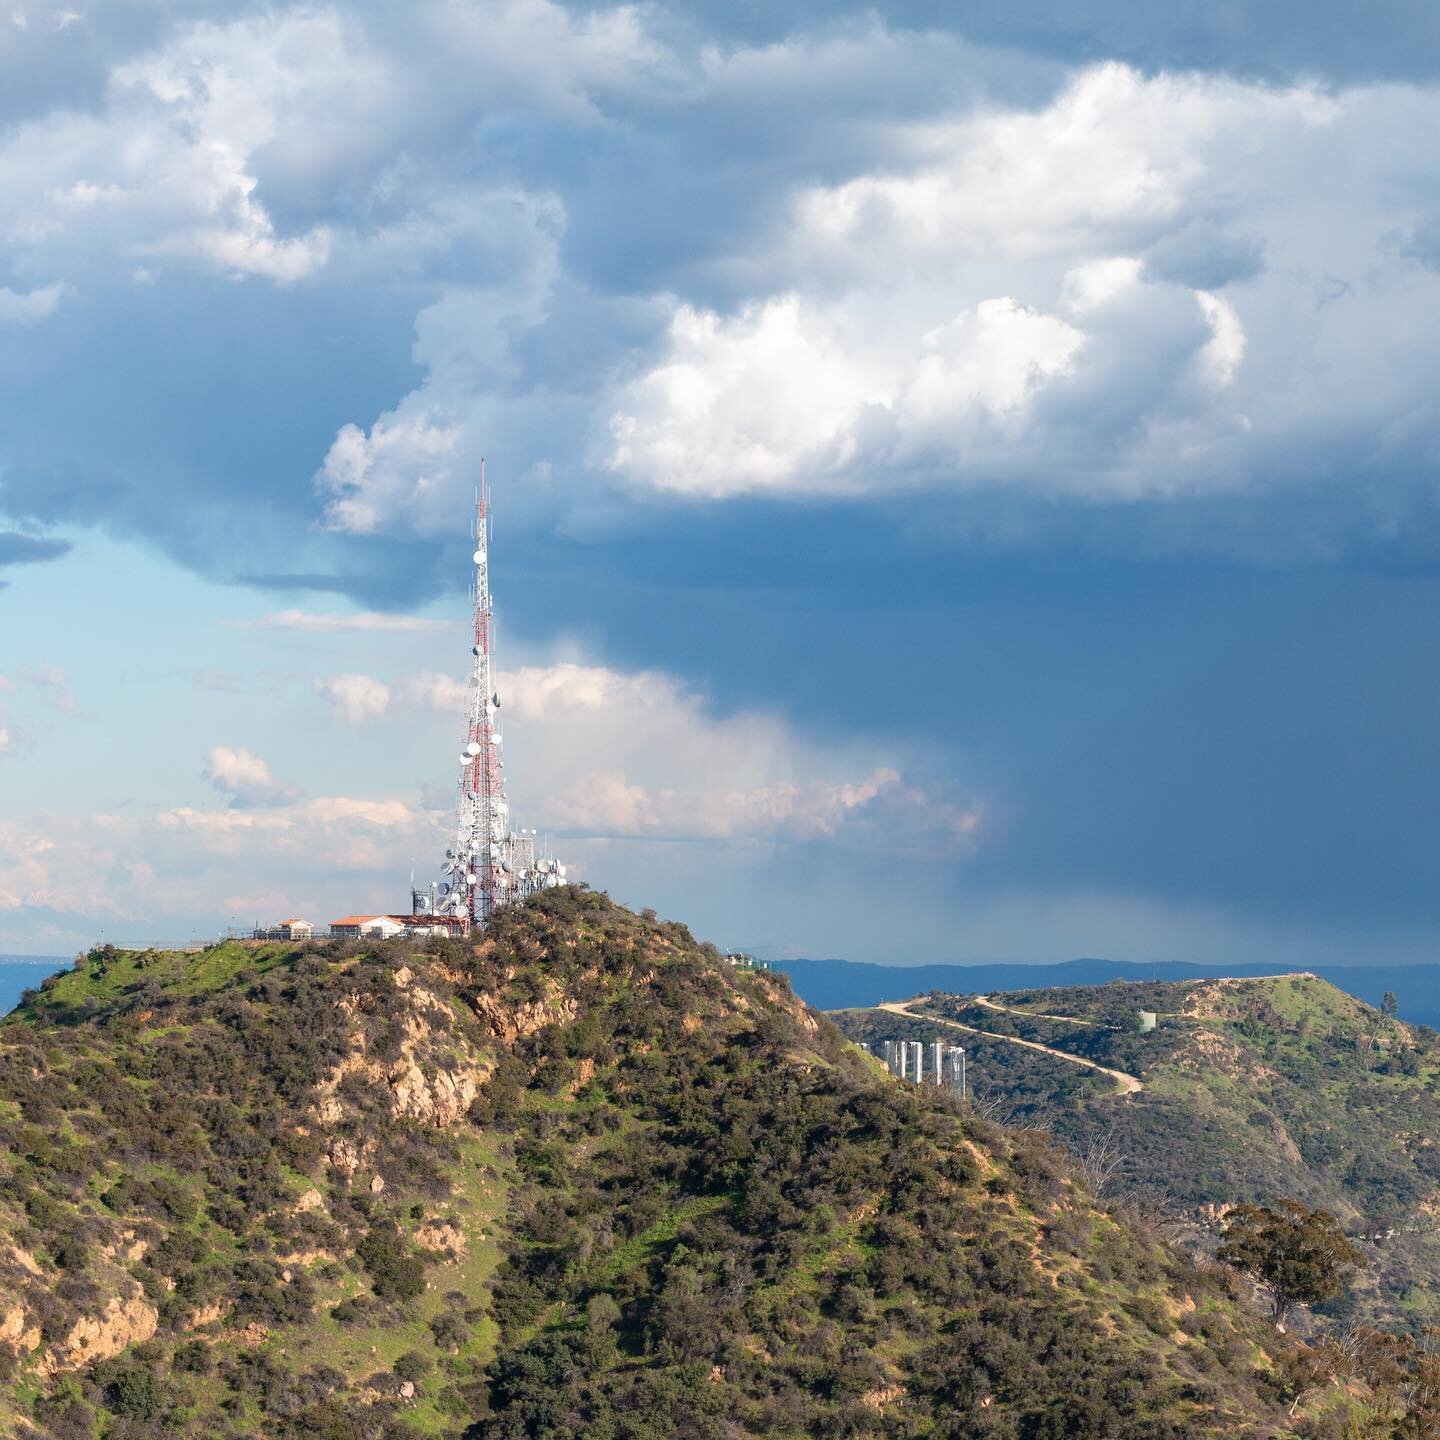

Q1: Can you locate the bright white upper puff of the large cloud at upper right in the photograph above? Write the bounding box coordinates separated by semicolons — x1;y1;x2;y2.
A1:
795;63;1319;275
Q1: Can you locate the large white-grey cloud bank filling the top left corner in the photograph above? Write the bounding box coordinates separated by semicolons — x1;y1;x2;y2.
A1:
0;0;665;295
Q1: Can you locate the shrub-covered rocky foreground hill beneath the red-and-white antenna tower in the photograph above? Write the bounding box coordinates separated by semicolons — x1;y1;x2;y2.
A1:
0;890;1388;1440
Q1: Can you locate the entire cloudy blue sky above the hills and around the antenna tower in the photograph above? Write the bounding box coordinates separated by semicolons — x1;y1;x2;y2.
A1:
0;0;1440;963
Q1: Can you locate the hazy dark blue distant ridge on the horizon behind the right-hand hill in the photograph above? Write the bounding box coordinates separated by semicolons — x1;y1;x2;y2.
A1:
775;959;1440;1030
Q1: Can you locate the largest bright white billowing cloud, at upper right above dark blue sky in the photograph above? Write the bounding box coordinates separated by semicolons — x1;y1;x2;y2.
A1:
596;65;1440;512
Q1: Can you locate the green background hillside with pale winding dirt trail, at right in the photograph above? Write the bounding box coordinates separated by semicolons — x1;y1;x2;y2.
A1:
841;975;1440;1328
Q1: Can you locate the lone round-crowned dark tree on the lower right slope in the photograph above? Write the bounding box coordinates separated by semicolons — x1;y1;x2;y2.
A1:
1218;1200;1365;1325
